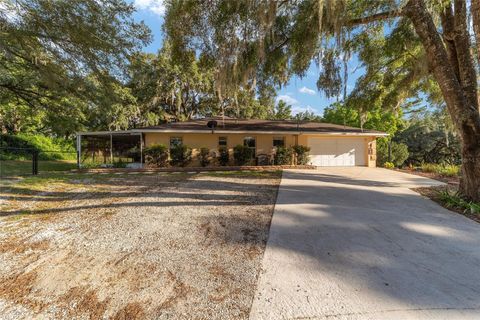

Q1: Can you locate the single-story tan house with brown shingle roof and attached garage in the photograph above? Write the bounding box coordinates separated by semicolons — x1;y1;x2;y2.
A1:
77;117;388;167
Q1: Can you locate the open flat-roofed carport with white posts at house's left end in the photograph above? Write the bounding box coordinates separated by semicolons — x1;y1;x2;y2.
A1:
77;131;144;168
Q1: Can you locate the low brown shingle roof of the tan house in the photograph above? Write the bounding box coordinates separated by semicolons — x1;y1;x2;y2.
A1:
140;117;385;135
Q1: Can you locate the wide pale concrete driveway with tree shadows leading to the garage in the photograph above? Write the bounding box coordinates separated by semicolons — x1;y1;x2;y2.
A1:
250;167;480;320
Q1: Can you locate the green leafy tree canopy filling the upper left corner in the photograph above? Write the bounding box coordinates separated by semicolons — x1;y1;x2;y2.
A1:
0;0;150;136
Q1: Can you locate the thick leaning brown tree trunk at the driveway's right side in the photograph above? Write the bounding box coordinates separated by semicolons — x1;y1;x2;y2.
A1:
403;0;480;202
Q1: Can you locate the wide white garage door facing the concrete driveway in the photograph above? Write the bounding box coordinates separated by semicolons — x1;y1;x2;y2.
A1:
308;138;365;167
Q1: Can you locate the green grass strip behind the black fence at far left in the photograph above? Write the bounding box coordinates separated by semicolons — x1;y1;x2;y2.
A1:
0;160;77;177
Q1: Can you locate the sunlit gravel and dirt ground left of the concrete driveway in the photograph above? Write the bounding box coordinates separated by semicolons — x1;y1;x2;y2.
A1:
0;172;280;319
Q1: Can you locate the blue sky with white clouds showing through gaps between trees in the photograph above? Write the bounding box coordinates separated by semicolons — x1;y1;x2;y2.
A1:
132;0;362;115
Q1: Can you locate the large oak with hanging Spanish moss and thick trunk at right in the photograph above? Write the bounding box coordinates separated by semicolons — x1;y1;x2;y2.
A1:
165;0;480;201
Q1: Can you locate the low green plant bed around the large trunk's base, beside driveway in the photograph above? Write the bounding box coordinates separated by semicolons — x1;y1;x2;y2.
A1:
412;184;480;223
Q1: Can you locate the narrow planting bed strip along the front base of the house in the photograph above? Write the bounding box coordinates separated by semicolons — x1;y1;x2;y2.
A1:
77;165;317;172
